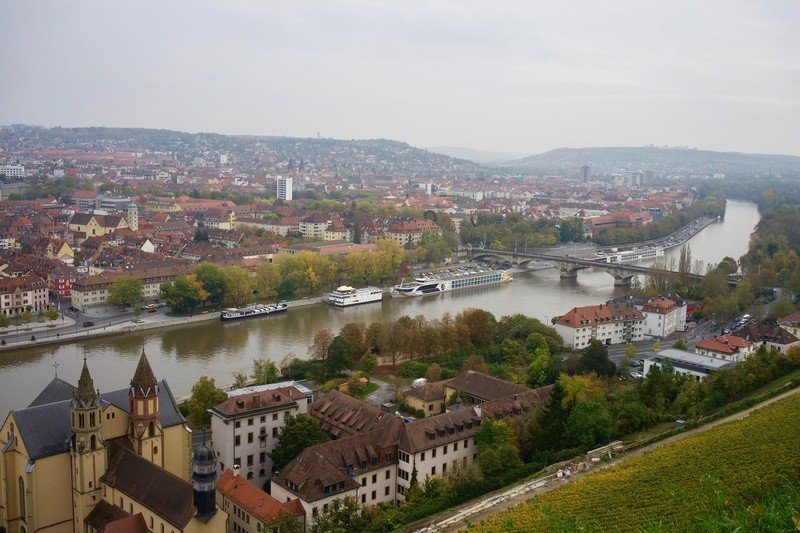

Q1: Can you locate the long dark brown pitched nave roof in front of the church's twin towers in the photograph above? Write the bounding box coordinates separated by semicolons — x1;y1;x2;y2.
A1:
100;443;196;530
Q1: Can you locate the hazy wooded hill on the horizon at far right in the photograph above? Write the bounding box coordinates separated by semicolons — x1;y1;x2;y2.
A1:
507;146;800;173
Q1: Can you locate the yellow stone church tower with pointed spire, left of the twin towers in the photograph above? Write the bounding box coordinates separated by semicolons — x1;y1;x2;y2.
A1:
69;359;107;531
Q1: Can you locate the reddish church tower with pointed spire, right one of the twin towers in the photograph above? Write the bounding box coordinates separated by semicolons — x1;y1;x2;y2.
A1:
128;349;164;468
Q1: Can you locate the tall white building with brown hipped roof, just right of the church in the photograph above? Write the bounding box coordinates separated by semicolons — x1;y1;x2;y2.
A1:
210;381;314;487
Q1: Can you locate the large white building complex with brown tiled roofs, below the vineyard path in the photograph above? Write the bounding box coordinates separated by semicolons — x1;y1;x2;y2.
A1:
270;378;552;524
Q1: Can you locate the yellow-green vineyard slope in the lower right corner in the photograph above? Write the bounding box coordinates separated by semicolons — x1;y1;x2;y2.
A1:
470;394;800;532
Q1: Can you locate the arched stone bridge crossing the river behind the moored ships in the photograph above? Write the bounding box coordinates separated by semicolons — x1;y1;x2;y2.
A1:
467;248;712;287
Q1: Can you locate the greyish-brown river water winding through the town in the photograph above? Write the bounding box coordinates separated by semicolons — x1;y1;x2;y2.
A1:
0;200;760;413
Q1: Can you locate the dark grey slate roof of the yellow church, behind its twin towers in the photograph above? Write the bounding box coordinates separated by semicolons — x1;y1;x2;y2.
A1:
11;380;185;461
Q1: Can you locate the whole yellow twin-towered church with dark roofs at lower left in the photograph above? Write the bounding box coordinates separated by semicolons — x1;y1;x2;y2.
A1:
0;351;227;533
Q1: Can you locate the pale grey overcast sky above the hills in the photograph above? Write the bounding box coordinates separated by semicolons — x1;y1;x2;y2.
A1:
0;0;800;155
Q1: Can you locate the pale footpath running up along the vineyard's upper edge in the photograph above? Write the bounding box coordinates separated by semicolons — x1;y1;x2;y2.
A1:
416;388;800;533
